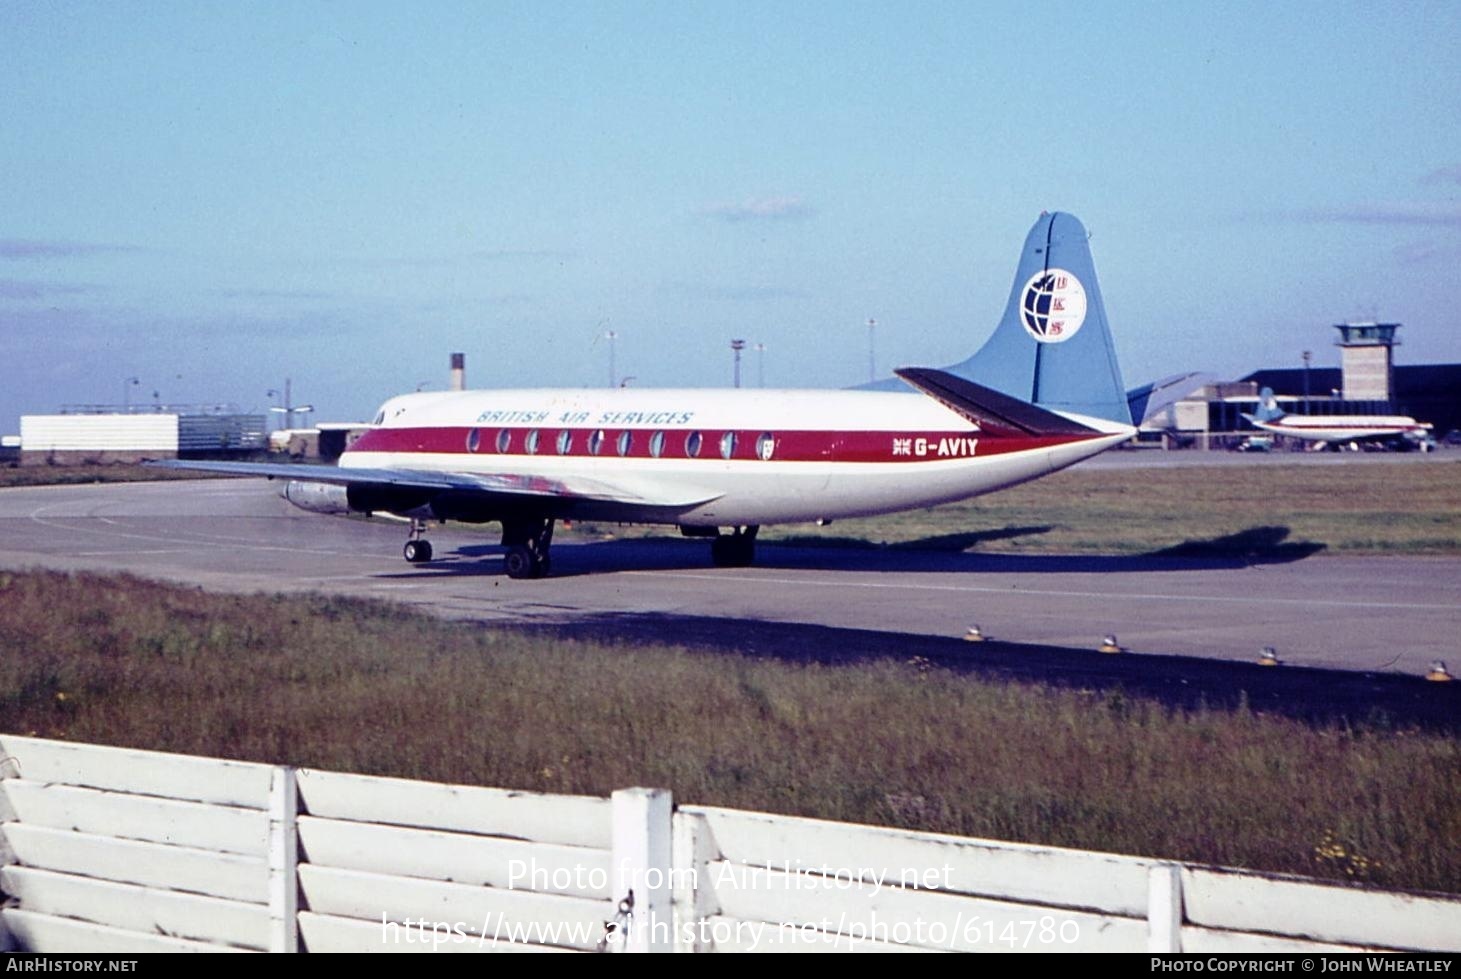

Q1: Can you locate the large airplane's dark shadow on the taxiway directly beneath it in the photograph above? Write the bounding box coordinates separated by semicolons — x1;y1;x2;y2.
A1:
381;526;1325;577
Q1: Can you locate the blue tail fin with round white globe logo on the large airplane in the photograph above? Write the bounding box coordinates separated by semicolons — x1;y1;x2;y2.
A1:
945;212;1131;425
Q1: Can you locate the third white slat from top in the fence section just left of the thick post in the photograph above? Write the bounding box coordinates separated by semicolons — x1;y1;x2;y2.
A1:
300;864;614;948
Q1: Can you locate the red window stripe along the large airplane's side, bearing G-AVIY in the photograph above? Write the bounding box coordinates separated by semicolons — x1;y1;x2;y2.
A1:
351;427;1094;462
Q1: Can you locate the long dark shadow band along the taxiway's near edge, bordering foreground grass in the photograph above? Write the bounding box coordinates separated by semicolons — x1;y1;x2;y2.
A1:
507;612;1461;732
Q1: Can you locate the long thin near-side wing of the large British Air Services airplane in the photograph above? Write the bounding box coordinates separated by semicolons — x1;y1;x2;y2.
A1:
146;459;719;507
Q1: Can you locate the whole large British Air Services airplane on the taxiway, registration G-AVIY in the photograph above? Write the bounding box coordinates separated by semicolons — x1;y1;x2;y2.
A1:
153;212;1135;579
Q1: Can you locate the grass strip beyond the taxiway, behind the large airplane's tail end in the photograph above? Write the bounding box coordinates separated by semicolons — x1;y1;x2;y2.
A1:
566;459;1461;555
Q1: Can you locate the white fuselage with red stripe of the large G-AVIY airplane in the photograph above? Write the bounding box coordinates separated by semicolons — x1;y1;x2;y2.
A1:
340;389;1134;527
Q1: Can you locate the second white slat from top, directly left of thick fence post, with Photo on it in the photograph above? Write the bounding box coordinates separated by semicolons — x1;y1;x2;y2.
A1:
300;815;611;899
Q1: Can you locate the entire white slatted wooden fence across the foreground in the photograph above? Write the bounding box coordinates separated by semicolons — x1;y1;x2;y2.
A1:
0;735;1461;953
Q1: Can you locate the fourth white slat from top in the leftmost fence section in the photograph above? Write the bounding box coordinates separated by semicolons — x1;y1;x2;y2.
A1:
0;866;269;951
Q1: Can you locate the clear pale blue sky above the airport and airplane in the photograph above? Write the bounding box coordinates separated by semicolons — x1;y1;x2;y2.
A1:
0;0;1461;433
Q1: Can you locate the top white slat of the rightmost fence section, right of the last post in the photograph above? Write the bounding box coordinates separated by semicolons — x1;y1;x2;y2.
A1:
1182;868;1461;951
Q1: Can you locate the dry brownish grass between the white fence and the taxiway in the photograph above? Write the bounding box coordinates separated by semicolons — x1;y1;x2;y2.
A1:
0;573;1461;893
